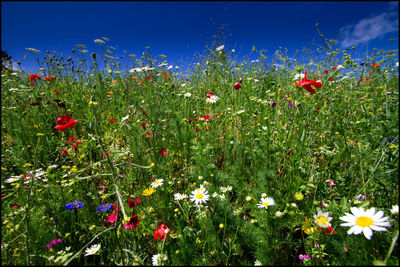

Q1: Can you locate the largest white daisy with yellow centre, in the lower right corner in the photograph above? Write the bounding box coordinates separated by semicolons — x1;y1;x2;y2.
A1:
340;207;390;240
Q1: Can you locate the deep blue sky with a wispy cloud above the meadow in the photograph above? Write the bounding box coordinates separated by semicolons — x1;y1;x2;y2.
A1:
1;1;399;73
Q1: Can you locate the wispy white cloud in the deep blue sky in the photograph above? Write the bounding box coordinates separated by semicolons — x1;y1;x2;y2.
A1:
339;12;399;48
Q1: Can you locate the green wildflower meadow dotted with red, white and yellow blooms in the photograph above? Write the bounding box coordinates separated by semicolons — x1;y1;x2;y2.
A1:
1;35;399;266
